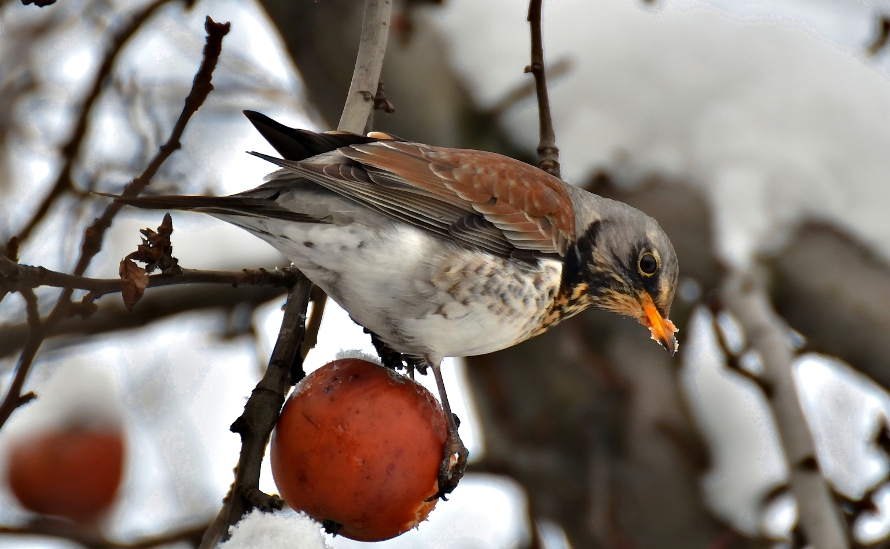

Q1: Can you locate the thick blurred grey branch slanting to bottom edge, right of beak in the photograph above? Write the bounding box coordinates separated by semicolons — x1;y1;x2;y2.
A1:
721;272;850;549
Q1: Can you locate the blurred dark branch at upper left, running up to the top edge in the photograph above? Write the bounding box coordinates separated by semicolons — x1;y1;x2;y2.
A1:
10;0;184;246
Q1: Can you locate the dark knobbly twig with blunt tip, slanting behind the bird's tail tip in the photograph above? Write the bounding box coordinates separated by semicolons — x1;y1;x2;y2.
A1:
0;17;229;428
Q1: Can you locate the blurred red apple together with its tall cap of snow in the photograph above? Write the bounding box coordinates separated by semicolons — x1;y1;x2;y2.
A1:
0;361;128;528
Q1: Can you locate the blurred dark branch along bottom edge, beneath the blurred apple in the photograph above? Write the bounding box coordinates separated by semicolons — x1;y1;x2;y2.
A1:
0;519;207;549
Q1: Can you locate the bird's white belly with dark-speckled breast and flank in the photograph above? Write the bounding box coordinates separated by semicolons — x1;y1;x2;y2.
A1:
220;216;562;359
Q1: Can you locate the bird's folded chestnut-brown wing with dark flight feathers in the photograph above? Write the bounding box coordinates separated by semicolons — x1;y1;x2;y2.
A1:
248;140;575;259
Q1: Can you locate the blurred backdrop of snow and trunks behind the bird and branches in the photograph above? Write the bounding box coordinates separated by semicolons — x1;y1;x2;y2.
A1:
0;0;890;549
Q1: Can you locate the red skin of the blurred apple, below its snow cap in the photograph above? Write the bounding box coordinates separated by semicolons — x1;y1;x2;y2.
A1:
6;427;124;524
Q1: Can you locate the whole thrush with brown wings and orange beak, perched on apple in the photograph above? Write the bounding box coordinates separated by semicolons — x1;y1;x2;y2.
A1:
116;111;679;498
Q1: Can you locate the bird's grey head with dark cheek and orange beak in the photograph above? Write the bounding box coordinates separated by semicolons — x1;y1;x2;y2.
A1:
567;195;679;354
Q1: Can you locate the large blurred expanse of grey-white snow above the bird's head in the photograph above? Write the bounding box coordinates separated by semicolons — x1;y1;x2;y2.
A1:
437;0;890;265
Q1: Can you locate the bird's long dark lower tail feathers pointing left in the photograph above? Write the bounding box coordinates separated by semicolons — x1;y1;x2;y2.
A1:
114;195;325;223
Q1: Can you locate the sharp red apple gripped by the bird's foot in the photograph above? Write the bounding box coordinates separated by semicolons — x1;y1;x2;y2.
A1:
271;359;447;541
